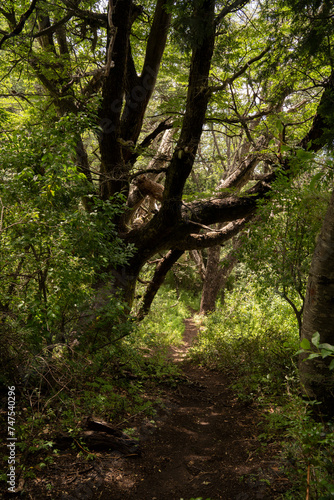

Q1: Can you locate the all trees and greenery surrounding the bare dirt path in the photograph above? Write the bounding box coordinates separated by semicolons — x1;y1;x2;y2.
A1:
0;0;334;500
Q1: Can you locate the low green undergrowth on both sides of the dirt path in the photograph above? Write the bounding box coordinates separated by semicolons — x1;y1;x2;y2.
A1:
1;282;334;500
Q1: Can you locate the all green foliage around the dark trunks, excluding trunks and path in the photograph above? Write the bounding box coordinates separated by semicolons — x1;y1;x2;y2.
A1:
0;0;334;495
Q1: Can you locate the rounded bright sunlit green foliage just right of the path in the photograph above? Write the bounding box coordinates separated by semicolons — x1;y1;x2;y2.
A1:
192;280;298;401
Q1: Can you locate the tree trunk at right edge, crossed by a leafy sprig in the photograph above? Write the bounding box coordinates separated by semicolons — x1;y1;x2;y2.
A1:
299;191;334;415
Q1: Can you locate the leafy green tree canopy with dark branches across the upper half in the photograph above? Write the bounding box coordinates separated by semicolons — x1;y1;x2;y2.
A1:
0;0;334;328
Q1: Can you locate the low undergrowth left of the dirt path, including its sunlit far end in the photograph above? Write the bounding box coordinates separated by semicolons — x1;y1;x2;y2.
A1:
0;291;185;488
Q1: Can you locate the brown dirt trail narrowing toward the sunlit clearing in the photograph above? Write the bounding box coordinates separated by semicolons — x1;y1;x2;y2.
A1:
107;318;287;500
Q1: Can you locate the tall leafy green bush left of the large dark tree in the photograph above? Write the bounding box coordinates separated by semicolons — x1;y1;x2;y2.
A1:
0;115;135;382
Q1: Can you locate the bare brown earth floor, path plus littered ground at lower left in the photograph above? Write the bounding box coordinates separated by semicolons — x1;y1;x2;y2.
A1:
6;319;289;500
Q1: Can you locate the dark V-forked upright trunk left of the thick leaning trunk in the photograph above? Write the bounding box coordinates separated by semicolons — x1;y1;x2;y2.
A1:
99;0;170;200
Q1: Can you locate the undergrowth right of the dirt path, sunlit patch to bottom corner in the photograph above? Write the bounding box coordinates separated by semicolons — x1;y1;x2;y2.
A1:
191;283;334;500
